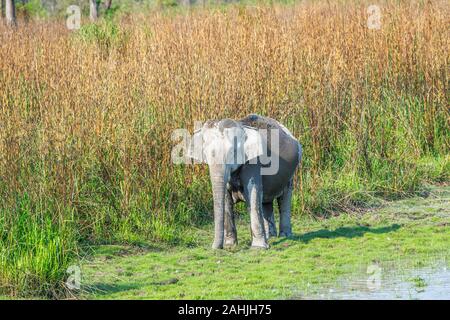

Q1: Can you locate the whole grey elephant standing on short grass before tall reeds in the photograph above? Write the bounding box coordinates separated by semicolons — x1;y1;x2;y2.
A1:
187;114;302;249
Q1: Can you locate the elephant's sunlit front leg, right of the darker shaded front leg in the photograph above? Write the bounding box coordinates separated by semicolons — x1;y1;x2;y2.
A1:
241;167;269;249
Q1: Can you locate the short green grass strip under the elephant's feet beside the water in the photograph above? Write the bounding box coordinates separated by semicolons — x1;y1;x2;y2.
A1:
81;187;450;299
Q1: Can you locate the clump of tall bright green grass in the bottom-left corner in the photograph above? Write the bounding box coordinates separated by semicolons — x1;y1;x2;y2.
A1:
0;194;77;298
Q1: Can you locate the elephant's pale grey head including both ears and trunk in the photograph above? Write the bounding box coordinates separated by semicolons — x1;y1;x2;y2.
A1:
188;119;263;249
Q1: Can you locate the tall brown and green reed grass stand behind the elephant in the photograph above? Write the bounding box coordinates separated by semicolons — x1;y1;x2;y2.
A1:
0;1;450;297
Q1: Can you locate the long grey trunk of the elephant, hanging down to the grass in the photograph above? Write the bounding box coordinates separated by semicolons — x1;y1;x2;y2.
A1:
209;165;228;249
